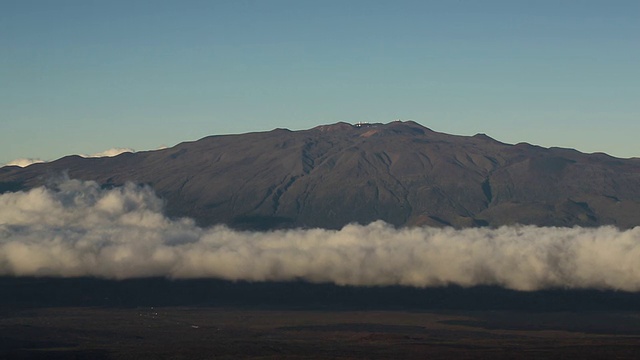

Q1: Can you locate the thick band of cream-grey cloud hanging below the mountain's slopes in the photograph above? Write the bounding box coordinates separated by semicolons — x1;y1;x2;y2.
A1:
0;180;640;291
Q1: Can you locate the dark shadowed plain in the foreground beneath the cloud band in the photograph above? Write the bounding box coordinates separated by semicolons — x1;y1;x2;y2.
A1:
0;277;640;359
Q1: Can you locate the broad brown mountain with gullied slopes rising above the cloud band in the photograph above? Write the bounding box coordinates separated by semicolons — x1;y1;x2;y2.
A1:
0;121;640;229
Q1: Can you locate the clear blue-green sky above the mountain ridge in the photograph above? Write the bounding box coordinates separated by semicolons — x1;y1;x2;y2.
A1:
0;0;640;164
